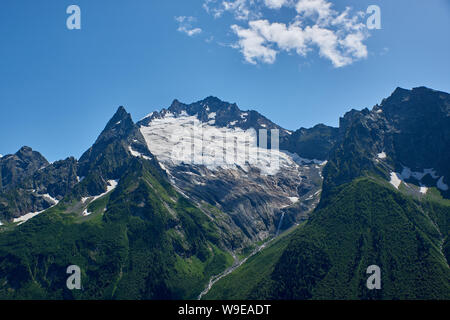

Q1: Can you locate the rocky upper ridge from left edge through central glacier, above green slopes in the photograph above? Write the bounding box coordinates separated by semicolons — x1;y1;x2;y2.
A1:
0;97;326;249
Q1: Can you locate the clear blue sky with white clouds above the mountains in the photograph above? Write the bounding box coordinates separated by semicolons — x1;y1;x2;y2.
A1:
0;0;450;161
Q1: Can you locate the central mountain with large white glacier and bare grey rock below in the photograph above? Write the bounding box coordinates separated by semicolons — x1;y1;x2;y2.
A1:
138;97;323;242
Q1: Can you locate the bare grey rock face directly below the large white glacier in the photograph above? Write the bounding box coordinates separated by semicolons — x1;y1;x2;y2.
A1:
160;163;322;241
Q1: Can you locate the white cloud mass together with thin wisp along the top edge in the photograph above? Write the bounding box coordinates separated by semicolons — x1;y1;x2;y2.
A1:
204;0;369;68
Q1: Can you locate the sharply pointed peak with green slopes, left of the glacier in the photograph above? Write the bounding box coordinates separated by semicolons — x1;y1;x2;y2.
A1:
0;108;239;299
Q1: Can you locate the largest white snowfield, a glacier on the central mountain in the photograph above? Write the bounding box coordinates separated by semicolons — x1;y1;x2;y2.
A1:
140;116;296;175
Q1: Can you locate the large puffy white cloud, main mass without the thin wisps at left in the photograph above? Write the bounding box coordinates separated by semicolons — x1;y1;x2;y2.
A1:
232;0;368;68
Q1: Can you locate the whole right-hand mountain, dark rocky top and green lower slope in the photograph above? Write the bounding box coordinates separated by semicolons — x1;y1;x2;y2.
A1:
207;88;450;299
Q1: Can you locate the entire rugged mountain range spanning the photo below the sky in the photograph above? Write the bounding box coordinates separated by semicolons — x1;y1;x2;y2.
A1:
0;87;450;299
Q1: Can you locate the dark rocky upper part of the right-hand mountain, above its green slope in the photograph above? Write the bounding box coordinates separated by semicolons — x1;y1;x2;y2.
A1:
324;87;450;197
